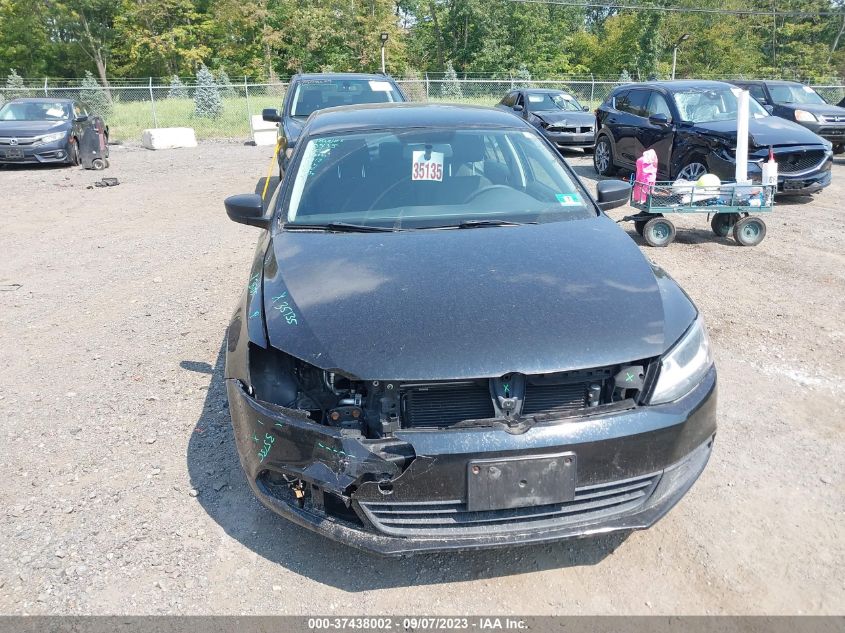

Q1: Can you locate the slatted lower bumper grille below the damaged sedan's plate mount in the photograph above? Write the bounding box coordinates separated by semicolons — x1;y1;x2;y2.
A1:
360;473;660;537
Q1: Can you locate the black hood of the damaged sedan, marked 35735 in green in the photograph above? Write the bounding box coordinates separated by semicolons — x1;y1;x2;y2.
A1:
264;216;695;380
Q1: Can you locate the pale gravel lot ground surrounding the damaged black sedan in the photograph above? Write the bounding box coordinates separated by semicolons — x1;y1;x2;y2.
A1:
0;143;845;615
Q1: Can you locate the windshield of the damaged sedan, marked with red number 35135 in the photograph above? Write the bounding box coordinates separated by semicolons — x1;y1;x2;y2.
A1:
282;129;596;229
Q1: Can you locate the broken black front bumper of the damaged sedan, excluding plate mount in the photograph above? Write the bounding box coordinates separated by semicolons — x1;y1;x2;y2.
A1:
227;369;716;555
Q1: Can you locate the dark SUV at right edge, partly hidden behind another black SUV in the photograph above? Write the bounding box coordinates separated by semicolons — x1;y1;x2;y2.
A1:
733;81;845;154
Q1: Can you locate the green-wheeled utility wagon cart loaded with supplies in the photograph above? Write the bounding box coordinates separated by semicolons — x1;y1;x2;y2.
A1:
622;181;775;246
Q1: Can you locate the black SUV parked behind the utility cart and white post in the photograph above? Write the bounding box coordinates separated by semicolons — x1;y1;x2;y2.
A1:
593;81;833;194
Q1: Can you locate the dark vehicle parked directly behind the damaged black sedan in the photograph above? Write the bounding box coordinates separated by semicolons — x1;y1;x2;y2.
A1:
261;73;407;173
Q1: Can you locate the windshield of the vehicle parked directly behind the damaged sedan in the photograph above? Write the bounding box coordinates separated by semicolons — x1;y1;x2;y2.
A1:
290;79;404;117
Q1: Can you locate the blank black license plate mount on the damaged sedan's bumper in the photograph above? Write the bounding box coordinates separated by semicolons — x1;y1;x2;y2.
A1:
467;453;576;512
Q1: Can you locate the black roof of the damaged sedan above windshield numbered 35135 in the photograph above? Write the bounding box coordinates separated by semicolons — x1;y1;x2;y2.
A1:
307;103;531;134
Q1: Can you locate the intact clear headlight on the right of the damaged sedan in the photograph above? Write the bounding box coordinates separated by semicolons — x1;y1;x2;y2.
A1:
651;315;713;404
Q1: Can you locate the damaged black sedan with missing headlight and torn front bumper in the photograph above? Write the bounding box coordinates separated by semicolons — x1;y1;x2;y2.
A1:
225;104;716;554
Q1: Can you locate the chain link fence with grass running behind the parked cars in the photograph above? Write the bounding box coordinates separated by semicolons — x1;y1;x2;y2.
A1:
0;76;845;142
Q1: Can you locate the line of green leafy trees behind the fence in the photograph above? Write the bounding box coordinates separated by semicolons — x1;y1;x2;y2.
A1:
0;0;845;86
